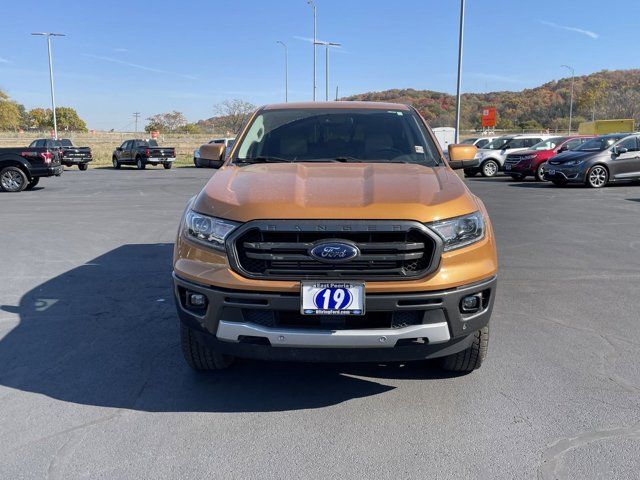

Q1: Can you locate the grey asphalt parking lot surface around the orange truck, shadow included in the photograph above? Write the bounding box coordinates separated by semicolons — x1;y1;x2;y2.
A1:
0;168;640;479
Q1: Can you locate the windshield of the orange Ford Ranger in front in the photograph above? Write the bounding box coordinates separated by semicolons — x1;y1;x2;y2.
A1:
233;108;439;166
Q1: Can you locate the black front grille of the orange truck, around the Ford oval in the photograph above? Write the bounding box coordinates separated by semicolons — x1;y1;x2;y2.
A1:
228;221;441;280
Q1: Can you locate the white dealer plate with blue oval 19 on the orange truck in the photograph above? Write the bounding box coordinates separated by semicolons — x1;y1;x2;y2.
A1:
300;282;364;315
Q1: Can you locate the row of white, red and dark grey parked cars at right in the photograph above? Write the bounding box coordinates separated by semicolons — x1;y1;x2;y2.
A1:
465;133;640;188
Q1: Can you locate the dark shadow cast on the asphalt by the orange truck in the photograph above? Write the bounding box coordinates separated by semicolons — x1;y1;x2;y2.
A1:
0;244;456;412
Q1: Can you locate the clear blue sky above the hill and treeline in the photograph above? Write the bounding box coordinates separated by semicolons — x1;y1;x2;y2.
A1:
0;0;640;129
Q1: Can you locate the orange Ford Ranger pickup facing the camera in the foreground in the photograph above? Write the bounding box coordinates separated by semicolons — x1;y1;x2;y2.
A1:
173;102;497;371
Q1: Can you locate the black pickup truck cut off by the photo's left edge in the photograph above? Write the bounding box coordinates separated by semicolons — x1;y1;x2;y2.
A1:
0;147;64;192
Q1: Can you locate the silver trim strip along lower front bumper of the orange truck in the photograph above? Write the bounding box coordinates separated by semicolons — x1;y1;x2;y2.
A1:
216;320;451;348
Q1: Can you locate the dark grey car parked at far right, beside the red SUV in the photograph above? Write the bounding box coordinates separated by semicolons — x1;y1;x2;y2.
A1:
544;133;640;188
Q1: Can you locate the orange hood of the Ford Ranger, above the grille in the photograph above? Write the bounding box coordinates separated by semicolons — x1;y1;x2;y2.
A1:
193;163;478;222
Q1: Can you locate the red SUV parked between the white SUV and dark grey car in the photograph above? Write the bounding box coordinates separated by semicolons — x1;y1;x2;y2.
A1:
504;135;594;182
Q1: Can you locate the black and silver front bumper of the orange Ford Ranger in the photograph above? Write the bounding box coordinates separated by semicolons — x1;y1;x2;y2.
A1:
173;273;496;361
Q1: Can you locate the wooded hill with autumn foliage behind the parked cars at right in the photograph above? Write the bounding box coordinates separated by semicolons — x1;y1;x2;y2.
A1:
341;69;640;130
